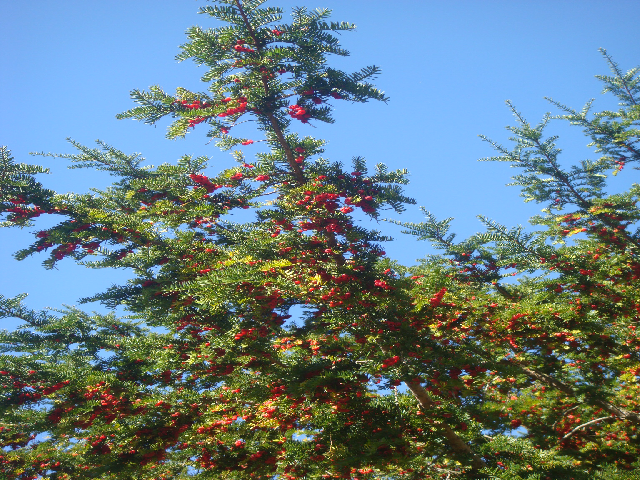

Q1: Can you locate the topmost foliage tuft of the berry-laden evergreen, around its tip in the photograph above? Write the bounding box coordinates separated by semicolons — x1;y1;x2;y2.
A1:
118;2;387;144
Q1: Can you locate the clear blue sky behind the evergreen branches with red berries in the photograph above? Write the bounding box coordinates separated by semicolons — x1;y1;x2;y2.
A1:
0;0;640;318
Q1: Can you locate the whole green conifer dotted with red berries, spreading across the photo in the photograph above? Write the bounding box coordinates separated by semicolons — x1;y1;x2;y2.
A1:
0;0;640;480
